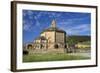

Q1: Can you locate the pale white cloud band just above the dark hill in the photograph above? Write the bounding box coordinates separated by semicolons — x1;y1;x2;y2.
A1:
62;24;91;35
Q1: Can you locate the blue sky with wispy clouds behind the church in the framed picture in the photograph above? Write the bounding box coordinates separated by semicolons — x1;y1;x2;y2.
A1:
22;10;91;43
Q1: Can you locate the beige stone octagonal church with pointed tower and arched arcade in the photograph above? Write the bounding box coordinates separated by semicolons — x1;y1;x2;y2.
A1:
26;20;67;53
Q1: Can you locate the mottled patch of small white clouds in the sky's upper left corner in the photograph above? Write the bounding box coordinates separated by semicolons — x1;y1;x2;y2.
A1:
23;10;42;32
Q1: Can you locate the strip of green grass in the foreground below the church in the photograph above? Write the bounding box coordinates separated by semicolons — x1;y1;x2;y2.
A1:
23;54;89;62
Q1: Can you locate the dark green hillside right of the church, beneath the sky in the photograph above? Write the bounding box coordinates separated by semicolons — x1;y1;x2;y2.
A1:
66;35;91;43
